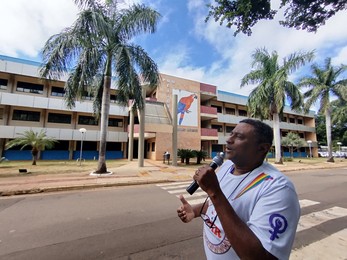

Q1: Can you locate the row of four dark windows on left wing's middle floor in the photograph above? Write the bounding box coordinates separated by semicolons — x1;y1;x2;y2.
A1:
12;109;123;127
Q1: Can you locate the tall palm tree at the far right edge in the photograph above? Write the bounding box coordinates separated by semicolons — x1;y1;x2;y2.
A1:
299;58;347;162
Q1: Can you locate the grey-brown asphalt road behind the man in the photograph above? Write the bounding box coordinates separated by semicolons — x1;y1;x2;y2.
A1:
0;169;347;260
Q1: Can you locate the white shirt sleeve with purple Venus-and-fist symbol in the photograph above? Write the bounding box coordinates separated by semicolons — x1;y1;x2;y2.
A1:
247;180;300;259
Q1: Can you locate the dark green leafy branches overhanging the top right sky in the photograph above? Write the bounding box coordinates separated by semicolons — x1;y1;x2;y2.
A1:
206;0;347;35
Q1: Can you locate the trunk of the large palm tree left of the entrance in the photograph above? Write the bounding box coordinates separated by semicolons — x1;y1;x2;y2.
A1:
95;74;111;173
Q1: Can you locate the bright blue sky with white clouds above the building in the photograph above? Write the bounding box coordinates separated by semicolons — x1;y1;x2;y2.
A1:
0;0;347;98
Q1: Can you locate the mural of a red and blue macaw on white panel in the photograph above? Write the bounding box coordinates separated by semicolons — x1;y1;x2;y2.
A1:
173;89;198;127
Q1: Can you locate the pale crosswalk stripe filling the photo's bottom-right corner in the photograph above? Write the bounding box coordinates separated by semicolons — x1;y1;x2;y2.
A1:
290;229;347;260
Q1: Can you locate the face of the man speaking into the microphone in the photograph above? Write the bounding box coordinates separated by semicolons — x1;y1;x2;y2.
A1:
225;123;263;166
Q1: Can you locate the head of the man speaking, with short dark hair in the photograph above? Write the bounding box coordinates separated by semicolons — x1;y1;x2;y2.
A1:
226;119;273;166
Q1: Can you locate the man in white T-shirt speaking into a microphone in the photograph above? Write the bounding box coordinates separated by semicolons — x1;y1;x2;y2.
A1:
177;119;300;259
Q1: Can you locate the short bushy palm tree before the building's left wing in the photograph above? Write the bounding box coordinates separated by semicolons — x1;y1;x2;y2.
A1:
6;130;57;165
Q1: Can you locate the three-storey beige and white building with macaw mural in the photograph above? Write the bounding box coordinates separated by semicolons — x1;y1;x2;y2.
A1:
0;55;317;160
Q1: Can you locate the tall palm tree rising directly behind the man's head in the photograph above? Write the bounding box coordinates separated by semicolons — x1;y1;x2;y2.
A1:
241;48;314;163
